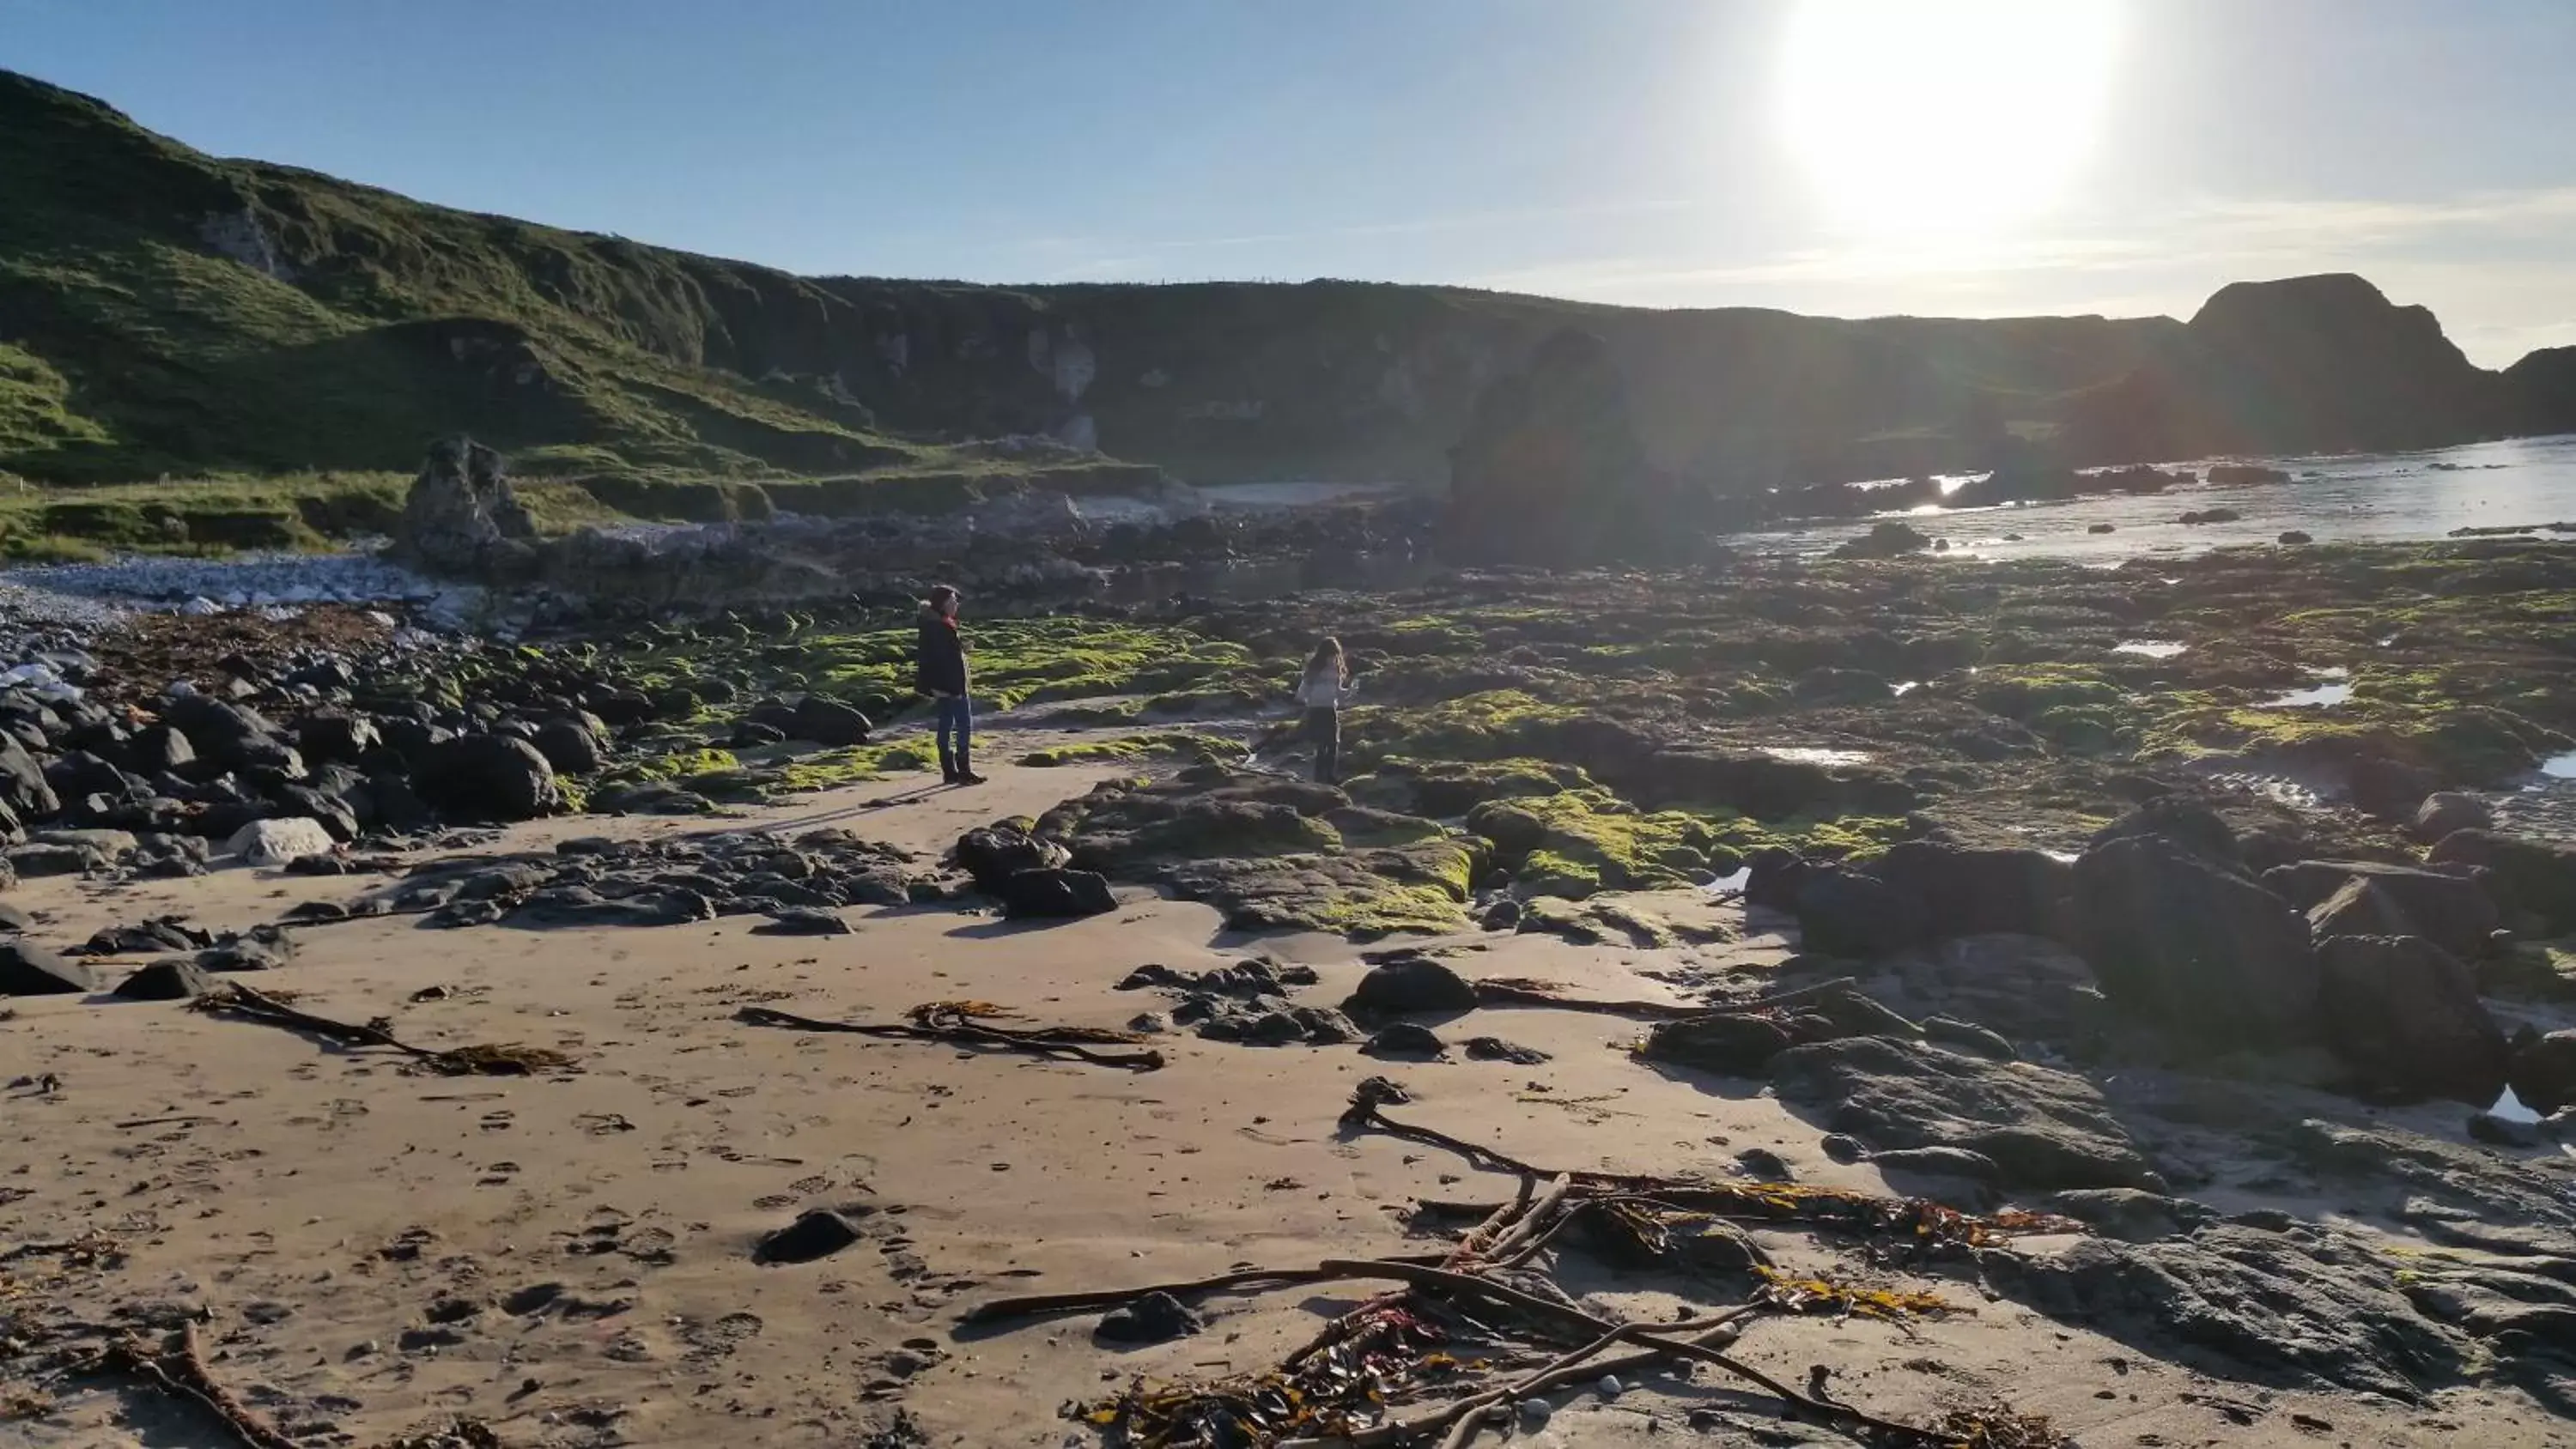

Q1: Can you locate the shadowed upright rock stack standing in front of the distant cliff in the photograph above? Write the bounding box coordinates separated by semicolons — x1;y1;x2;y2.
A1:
1443;327;1680;564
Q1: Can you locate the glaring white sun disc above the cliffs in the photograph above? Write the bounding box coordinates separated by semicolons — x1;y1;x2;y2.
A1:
1780;0;2120;234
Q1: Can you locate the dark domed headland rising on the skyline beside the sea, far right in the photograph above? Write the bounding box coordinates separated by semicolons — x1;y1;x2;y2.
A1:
2066;273;2512;461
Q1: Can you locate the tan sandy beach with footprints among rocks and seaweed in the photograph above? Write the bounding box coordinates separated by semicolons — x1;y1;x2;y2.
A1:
0;725;2571;1446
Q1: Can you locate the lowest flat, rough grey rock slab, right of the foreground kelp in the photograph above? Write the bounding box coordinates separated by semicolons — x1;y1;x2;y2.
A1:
1976;1225;2468;1403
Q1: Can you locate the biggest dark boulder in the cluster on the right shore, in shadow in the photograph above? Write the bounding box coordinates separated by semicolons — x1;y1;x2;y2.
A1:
2076;839;2318;1050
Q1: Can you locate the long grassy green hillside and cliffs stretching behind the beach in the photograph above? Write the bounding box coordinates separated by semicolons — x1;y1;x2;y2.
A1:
0;72;2514;537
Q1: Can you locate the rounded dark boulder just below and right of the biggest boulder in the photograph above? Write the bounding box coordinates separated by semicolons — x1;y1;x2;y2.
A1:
2316;937;2506;1106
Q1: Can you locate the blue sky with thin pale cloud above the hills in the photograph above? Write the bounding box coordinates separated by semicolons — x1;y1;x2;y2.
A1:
0;0;2576;366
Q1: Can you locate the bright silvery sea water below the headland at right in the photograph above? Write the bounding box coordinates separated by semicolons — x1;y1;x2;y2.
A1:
1734;435;2576;564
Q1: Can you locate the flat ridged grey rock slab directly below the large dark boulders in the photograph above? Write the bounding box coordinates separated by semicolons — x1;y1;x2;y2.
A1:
1770;1037;2151;1189
